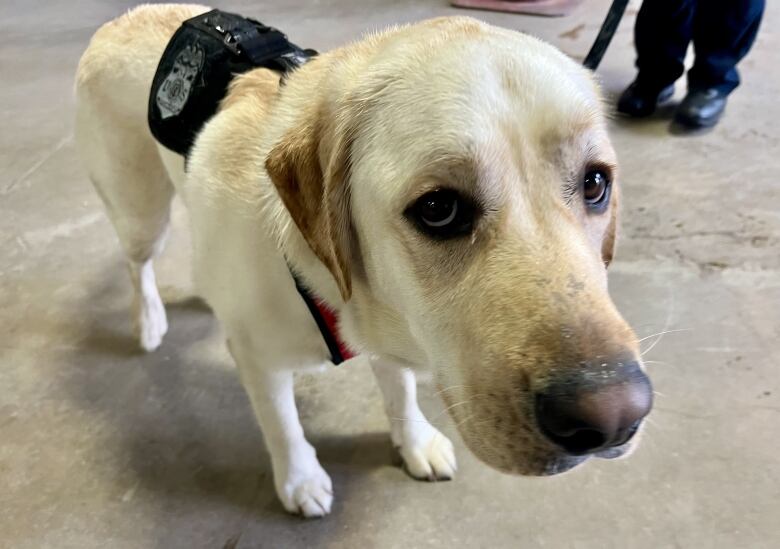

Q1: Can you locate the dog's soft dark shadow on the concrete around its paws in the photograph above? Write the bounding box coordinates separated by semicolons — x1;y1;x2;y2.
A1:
59;274;393;548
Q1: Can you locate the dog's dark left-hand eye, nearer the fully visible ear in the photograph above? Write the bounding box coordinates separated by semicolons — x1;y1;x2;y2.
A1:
406;189;474;239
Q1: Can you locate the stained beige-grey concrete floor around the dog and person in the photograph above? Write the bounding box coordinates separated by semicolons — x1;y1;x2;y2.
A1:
0;0;780;549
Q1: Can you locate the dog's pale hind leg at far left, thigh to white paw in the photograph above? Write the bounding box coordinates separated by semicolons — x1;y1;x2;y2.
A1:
76;96;174;351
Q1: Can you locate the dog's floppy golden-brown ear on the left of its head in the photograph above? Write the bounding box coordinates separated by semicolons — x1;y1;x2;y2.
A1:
265;112;352;301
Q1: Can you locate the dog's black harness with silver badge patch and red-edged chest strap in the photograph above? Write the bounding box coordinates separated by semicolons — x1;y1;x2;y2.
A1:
148;10;352;364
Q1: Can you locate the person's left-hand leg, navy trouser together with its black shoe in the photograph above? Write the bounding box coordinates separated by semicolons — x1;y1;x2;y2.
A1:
617;0;697;117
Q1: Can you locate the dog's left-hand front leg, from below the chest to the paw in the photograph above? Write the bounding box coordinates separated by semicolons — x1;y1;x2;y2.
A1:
228;340;333;517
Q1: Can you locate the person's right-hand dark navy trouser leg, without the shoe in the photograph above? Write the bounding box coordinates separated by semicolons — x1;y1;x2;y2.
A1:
688;0;764;95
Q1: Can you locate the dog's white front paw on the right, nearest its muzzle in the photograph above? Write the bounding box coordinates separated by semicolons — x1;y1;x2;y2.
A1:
393;422;458;481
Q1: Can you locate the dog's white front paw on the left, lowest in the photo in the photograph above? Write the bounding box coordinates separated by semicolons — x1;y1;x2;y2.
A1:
274;446;333;518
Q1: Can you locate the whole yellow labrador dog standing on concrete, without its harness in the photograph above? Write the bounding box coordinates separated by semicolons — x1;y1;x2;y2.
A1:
76;5;652;516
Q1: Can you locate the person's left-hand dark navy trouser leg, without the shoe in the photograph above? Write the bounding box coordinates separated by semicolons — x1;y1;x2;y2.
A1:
634;0;696;89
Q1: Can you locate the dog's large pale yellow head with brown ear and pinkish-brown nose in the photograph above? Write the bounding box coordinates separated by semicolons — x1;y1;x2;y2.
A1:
266;18;652;474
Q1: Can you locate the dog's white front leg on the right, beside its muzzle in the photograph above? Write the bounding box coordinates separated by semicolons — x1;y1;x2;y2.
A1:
371;360;457;480
